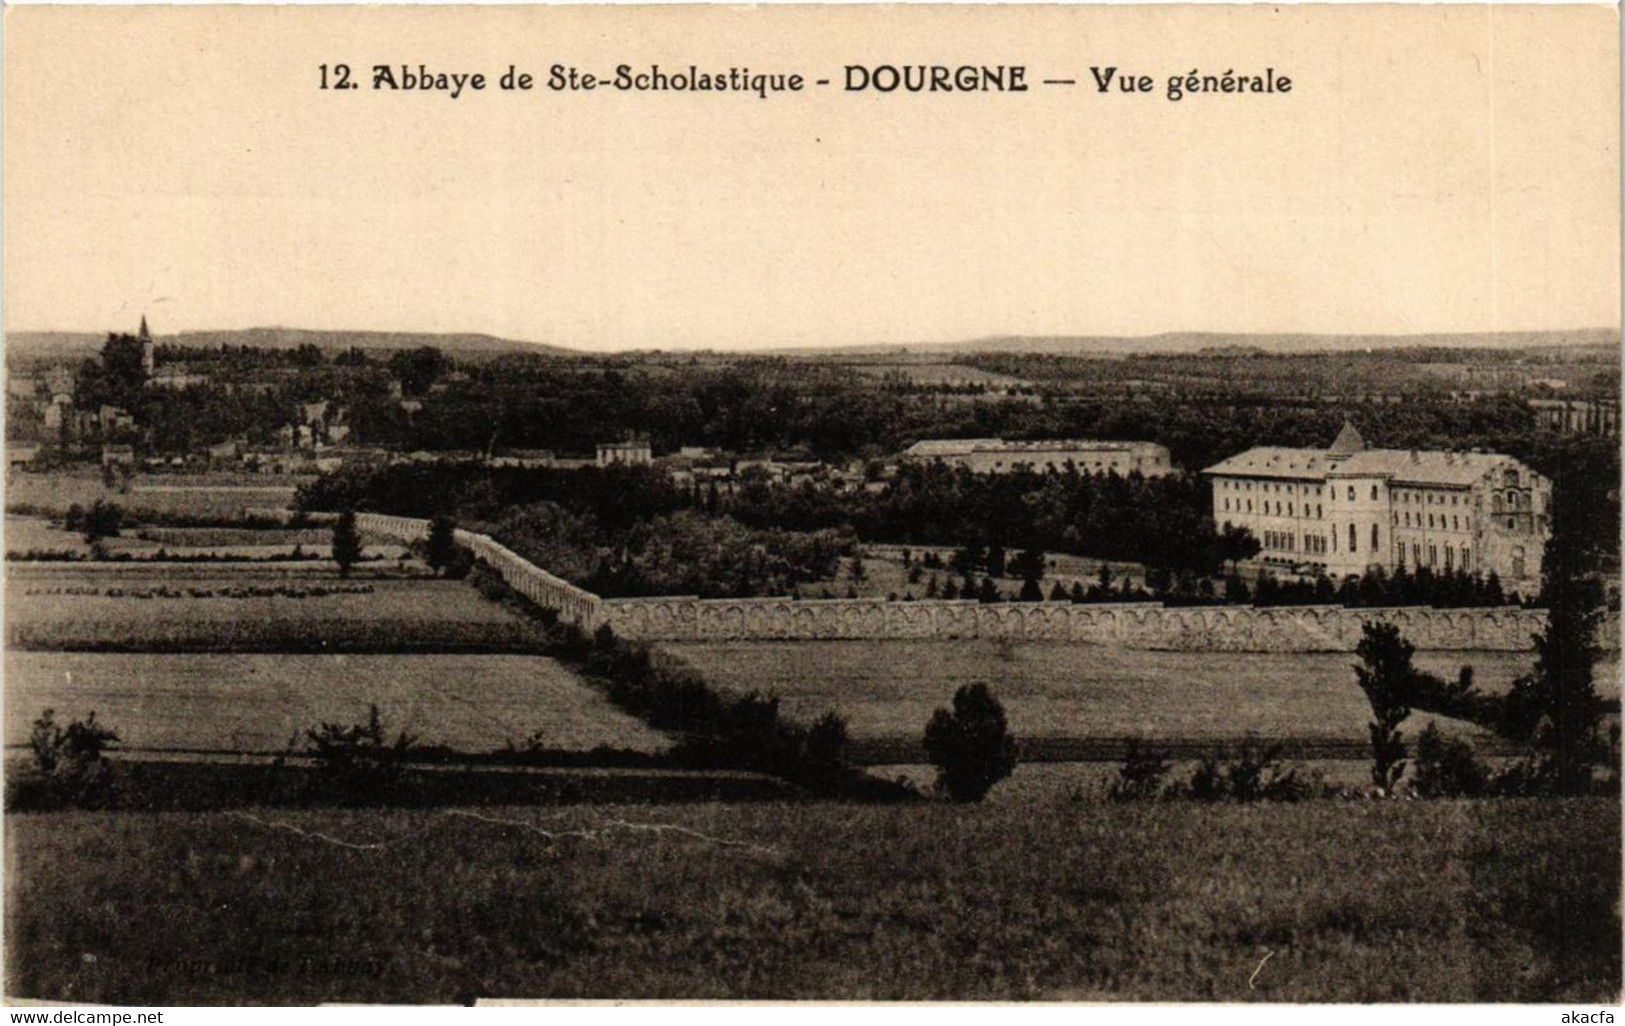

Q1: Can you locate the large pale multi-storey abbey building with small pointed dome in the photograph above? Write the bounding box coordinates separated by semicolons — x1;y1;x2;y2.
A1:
1204;424;1552;589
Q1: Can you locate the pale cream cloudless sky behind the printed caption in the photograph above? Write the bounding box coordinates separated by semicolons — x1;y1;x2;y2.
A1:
3;7;1620;350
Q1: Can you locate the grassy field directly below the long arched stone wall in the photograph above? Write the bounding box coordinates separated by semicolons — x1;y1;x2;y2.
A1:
666;641;1619;743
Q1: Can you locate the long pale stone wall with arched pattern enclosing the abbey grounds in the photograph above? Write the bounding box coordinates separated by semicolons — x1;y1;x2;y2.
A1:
313;514;1620;652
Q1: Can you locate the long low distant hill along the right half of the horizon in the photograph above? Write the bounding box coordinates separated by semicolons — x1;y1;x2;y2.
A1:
778;328;1620;356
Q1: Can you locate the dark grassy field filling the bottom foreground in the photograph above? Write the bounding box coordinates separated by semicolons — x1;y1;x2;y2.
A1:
5;800;1620;1005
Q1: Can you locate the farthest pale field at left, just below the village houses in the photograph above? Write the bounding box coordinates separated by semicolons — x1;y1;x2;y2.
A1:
5;473;309;517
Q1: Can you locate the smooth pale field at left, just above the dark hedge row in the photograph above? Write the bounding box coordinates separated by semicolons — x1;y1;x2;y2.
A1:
5;652;668;753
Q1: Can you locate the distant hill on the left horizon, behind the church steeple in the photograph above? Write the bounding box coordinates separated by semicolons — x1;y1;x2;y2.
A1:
5;328;577;359
